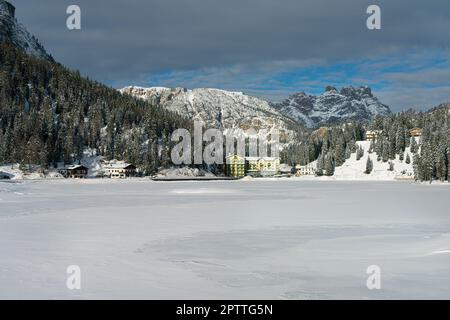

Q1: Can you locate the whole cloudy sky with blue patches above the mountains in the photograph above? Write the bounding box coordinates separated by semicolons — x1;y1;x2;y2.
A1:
10;0;450;111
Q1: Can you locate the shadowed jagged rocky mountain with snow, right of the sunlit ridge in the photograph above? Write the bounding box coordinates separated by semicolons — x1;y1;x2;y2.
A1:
272;86;391;127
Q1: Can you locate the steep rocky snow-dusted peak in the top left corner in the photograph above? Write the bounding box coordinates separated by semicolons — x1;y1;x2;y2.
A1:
0;0;53;61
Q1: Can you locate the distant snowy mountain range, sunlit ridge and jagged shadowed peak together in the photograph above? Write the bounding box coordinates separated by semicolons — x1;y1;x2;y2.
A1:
120;86;391;129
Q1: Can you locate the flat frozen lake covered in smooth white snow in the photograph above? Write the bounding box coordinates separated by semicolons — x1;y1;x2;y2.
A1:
0;180;450;299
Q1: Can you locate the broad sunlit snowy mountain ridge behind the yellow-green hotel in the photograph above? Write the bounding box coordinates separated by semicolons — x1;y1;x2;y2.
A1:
120;87;295;132
